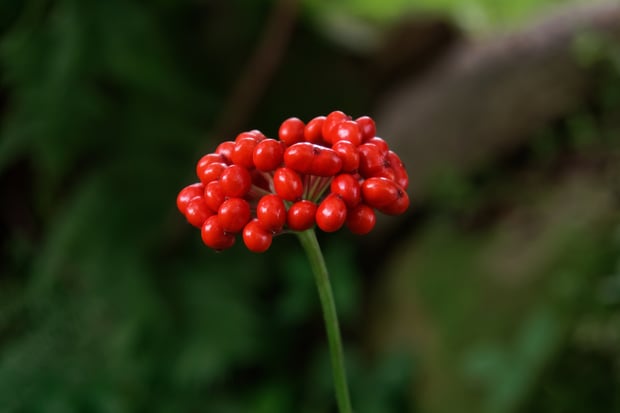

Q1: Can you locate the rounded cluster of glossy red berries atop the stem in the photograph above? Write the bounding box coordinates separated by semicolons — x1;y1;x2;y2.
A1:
177;111;409;252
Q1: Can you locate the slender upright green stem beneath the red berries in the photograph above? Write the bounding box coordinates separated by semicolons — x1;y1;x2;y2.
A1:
296;229;353;413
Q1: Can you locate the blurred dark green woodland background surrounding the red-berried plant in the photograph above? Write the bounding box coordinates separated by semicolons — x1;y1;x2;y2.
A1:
0;0;620;413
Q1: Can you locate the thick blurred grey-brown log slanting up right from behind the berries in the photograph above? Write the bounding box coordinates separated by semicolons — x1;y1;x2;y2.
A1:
375;1;620;200
